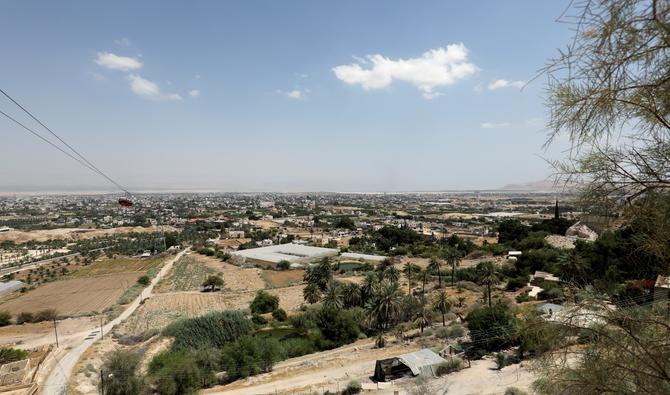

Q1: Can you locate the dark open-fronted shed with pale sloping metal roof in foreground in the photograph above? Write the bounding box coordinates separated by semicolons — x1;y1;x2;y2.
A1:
374;348;447;381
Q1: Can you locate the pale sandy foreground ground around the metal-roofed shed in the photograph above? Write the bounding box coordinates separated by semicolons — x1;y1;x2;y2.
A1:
207;339;537;395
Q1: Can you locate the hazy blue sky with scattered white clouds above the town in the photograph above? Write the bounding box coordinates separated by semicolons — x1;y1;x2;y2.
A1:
0;0;571;192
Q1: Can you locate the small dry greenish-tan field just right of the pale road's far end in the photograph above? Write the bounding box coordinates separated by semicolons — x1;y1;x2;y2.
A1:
155;255;222;293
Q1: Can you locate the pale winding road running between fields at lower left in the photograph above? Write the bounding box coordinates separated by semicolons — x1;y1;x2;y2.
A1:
41;249;188;395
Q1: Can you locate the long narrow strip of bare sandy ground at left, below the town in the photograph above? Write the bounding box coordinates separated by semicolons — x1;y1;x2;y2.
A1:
0;226;176;243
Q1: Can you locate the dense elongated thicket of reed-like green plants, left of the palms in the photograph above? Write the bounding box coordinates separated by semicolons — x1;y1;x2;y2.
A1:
163;310;252;350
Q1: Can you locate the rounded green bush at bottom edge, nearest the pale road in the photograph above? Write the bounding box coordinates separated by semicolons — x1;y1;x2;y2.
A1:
100;350;142;395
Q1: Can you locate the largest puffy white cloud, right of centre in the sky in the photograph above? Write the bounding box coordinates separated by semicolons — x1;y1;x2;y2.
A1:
333;43;478;99
